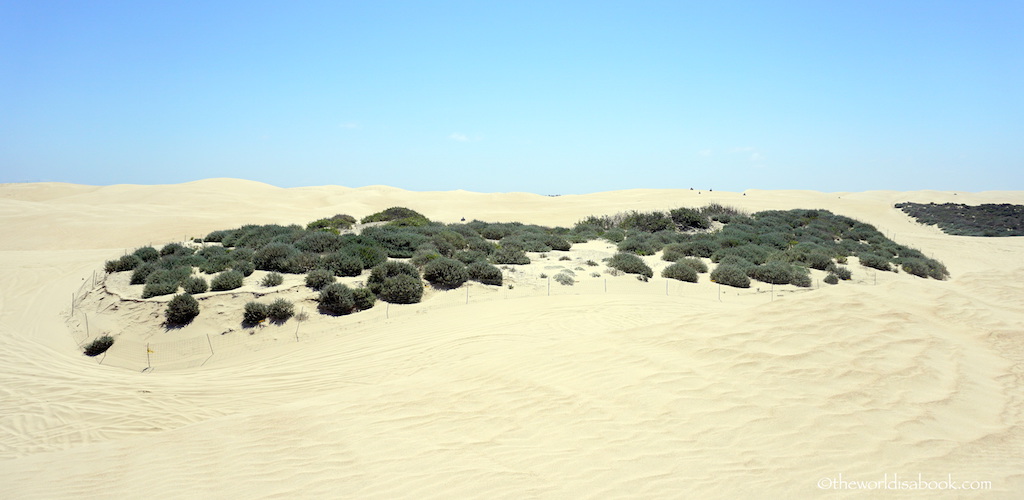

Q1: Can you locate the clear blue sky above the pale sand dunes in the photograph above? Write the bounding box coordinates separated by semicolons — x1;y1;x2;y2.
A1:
0;0;1024;194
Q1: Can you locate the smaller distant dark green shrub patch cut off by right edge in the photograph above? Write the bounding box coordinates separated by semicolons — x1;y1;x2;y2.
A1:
896;202;1024;237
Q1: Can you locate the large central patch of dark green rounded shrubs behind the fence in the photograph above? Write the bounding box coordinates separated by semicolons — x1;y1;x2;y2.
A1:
96;204;948;348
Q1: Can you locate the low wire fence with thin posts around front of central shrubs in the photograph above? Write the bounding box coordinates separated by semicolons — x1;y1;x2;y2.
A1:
67;272;878;372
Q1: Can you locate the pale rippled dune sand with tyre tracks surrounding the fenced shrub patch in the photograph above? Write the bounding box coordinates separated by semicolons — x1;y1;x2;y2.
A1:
0;179;1024;499
